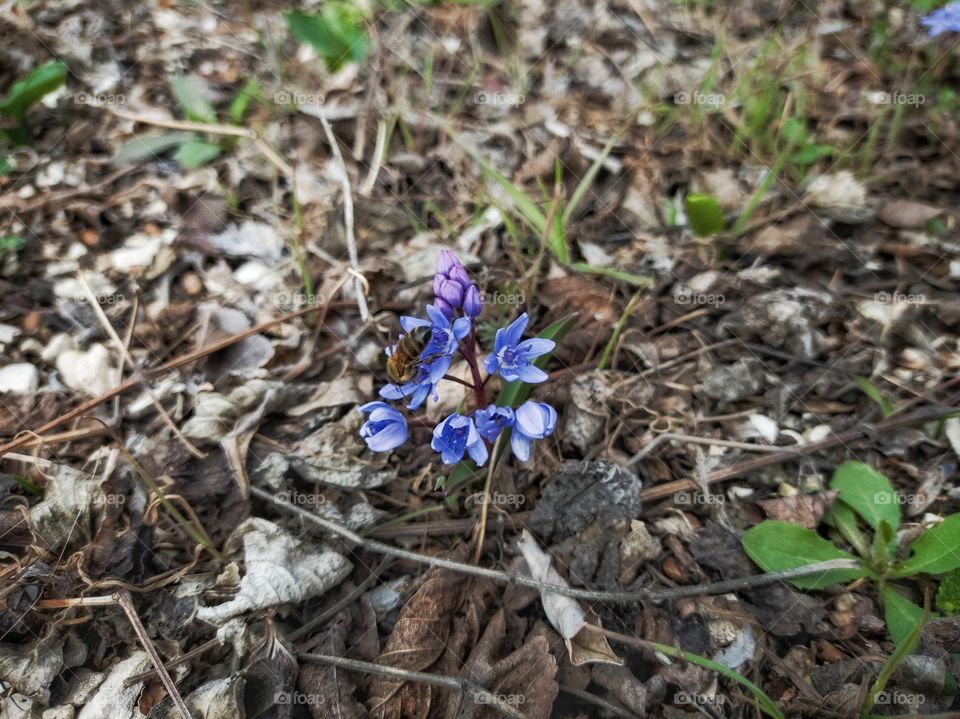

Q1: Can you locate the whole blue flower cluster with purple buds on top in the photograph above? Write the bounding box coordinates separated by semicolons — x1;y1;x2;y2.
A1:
359;250;557;466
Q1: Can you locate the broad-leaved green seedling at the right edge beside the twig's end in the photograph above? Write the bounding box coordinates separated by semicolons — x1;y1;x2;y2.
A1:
743;462;960;647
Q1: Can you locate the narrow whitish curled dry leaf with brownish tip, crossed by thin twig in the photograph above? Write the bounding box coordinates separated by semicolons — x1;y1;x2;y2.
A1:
519;530;623;666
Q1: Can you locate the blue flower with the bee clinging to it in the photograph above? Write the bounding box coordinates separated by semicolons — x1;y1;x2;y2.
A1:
380;305;471;409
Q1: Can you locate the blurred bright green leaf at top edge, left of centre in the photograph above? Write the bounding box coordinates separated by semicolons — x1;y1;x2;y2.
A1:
284;2;370;71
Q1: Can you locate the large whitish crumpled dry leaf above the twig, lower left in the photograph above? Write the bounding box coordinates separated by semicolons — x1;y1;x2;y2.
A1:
197;517;352;624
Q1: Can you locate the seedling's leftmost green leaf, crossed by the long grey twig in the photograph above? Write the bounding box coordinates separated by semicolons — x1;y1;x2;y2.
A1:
743;520;865;589
